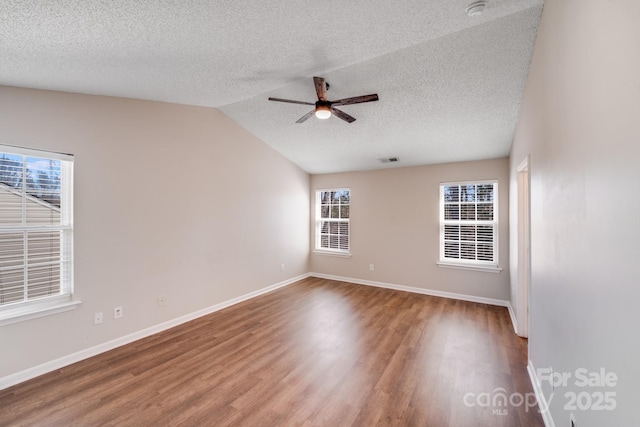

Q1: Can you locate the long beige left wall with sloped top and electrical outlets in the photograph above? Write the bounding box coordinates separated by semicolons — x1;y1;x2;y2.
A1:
0;87;309;379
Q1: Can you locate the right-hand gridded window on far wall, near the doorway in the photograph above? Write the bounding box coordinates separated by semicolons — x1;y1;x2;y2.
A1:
440;181;498;268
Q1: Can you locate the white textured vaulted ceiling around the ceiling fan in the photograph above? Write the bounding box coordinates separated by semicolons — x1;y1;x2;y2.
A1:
0;0;542;173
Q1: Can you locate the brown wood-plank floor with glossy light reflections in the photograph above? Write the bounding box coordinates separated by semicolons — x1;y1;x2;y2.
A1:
0;278;544;427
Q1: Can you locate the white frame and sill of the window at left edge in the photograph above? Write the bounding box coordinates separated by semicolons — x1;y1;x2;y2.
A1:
0;144;80;326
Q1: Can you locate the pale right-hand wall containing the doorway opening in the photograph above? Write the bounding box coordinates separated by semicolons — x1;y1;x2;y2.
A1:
510;0;640;427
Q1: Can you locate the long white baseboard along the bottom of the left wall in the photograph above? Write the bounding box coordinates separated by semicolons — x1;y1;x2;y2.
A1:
0;273;309;390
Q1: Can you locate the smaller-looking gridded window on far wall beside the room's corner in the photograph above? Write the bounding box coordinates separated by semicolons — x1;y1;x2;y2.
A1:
316;188;351;254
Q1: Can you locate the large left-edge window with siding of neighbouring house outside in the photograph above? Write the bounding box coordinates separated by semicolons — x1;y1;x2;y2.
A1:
0;146;77;323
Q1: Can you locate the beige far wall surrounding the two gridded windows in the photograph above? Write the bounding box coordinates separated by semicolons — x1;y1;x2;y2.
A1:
310;159;509;301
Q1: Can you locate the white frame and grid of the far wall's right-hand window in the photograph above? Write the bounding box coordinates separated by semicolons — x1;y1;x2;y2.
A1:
437;179;502;273
